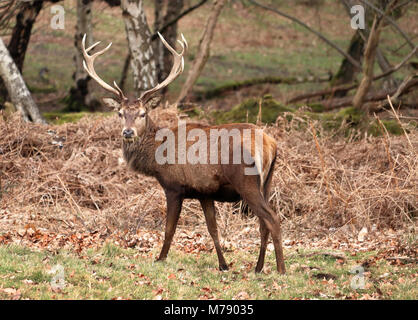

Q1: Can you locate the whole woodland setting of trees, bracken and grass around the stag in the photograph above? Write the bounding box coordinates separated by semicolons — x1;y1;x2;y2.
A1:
0;0;418;299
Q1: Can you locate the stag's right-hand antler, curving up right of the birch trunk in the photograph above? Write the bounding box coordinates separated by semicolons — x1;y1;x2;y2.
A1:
138;32;188;103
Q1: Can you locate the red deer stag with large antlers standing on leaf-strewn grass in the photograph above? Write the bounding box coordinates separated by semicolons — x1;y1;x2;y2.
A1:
82;35;285;273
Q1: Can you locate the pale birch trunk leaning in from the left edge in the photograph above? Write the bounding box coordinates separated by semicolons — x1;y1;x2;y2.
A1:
0;38;45;123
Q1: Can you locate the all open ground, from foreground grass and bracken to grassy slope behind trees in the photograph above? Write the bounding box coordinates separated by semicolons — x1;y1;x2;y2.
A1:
0;1;418;299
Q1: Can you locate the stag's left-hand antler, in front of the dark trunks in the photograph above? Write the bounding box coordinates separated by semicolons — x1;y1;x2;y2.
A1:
81;34;127;100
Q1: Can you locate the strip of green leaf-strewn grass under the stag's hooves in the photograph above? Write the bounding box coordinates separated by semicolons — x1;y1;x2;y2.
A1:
0;243;418;299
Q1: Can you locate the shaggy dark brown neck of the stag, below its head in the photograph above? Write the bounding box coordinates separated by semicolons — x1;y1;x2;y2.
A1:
122;115;159;176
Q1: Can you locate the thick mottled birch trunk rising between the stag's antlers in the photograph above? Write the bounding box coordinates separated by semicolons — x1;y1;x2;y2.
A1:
121;0;157;96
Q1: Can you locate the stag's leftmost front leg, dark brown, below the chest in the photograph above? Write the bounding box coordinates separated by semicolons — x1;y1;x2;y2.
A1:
157;192;183;261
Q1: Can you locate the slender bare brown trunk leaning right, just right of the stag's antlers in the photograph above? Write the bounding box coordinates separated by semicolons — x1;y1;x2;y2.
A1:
177;0;226;103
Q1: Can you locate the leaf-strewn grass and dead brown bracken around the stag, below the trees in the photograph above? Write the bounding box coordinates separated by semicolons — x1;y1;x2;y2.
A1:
0;108;418;299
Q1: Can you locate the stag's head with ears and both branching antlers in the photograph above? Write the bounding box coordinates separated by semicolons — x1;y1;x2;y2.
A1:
82;32;188;142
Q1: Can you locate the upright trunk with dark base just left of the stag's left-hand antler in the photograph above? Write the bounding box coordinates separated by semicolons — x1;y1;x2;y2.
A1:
66;0;95;112
